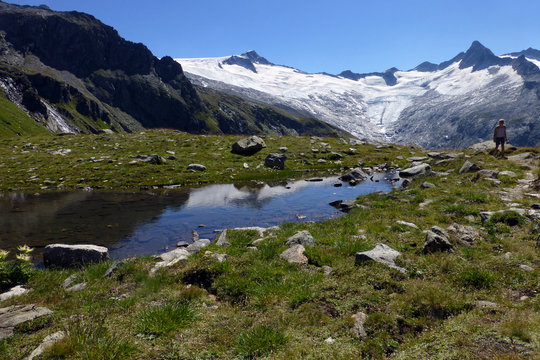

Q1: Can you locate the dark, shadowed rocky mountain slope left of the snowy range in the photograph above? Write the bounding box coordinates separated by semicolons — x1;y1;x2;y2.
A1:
0;2;341;135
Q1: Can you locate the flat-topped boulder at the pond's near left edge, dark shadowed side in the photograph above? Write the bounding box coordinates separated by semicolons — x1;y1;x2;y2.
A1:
43;244;109;268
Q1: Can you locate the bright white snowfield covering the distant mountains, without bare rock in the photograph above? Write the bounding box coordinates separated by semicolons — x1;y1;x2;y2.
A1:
175;57;524;140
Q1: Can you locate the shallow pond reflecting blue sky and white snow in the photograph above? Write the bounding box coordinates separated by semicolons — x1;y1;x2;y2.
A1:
0;174;392;262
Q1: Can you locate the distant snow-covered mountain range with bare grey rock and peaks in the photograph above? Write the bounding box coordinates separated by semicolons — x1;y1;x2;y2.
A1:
176;41;540;147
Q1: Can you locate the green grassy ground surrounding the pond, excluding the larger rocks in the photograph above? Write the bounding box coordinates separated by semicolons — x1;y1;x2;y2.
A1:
0;131;540;360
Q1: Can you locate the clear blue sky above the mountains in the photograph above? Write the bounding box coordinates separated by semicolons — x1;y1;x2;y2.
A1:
7;0;540;73
